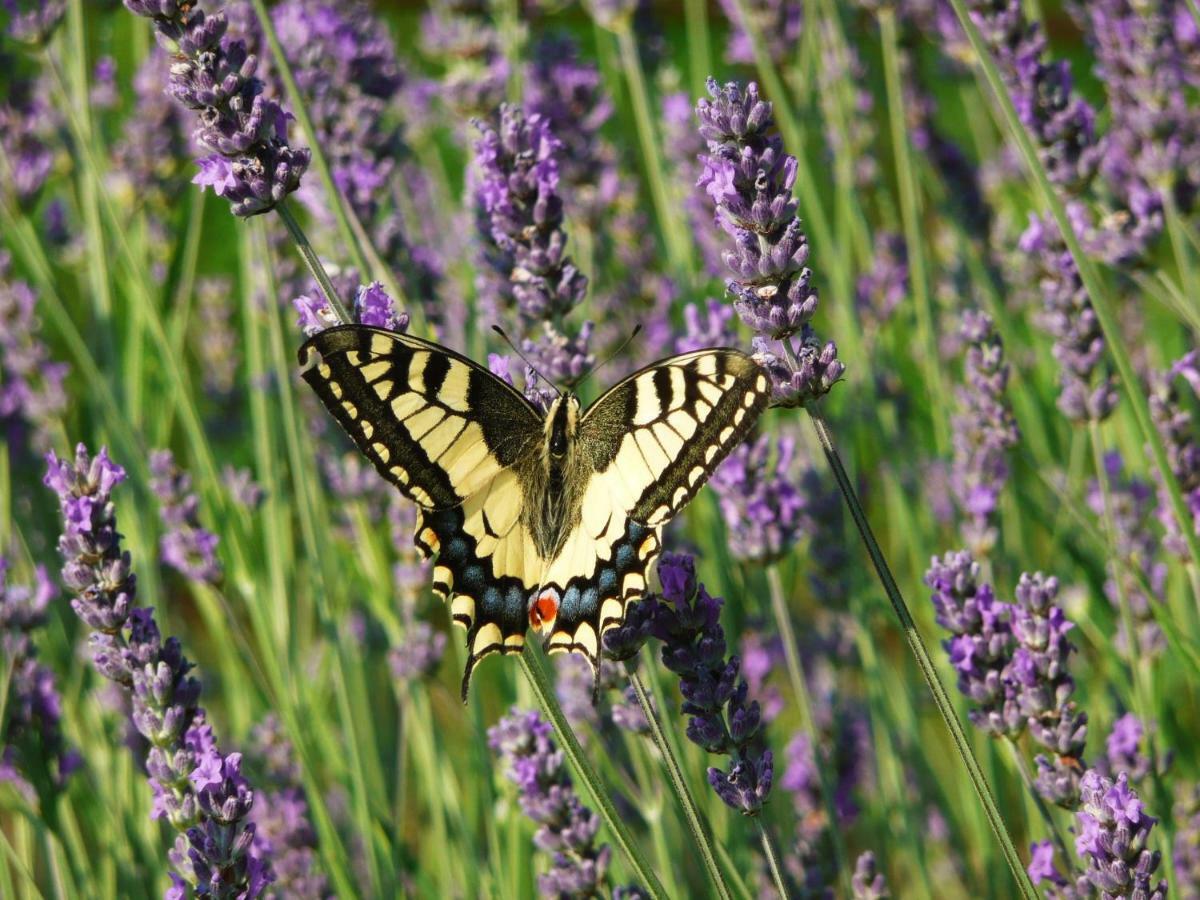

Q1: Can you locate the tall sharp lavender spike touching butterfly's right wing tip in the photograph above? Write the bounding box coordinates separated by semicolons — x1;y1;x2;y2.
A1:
696;79;845;406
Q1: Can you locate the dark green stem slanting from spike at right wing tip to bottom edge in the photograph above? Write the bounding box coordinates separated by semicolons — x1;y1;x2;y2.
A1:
808;404;1037;900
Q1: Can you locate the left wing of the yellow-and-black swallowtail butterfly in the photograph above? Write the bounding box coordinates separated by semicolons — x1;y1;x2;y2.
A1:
299;325;545;700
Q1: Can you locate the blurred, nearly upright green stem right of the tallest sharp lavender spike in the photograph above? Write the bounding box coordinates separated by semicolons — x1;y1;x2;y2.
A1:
880;14;950;456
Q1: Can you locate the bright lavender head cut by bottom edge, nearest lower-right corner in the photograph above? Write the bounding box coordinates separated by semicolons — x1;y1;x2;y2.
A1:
1075;769;1166;900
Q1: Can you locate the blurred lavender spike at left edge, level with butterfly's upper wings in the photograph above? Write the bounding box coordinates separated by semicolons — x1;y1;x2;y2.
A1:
0;250;70;451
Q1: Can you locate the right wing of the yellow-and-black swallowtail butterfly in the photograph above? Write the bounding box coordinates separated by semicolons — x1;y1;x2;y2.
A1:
542;349;770;668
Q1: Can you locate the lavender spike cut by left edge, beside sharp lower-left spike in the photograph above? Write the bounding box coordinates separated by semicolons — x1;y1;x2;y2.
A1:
0;557;80;802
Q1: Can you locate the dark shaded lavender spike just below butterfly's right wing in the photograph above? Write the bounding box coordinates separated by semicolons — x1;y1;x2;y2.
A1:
650;553;774;816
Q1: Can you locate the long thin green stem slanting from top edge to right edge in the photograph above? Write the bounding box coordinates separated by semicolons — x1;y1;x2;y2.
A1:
950;0;1200;588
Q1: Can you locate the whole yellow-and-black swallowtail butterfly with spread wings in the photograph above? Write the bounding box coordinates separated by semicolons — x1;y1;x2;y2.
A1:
299;325;770;702
